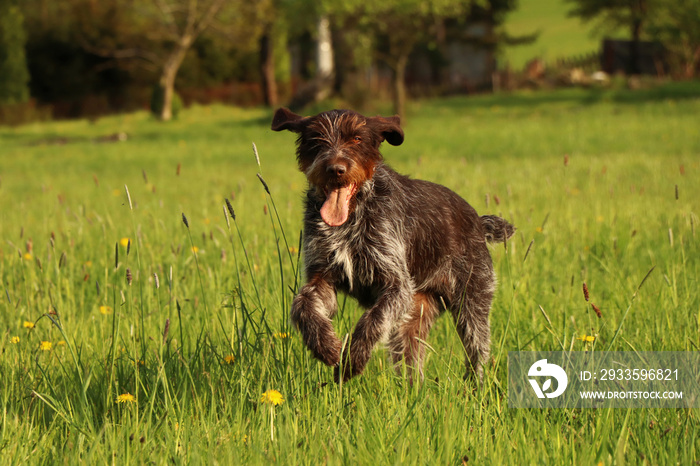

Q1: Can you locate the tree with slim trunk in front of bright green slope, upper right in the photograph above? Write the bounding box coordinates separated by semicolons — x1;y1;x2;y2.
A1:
567;0;655;74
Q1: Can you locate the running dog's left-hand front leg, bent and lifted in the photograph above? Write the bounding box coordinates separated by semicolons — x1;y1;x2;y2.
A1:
291;276;341;366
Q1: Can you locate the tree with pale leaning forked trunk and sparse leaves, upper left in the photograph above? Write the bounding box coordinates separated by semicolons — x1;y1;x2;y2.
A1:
75;0;245;121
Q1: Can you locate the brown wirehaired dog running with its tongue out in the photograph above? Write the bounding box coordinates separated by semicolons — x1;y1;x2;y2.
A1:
272;108;515;383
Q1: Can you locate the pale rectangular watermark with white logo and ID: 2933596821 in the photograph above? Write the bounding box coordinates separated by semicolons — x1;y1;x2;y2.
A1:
508;351;700;408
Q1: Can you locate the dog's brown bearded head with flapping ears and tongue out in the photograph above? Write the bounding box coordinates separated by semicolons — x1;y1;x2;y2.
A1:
272;108;403;226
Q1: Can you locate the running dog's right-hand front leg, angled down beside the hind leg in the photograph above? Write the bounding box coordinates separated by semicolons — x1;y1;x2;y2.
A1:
335;281;413;382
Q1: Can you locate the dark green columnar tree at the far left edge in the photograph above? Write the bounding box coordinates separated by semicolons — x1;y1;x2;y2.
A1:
0;0;29;104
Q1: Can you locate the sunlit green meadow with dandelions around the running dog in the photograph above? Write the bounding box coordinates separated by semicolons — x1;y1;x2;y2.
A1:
0;83;700;464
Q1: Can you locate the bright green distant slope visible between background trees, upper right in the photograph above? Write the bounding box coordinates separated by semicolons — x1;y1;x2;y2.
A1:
502;0;620;70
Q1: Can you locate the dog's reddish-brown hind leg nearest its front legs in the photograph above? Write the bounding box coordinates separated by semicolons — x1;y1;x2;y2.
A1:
389;293;440;383
